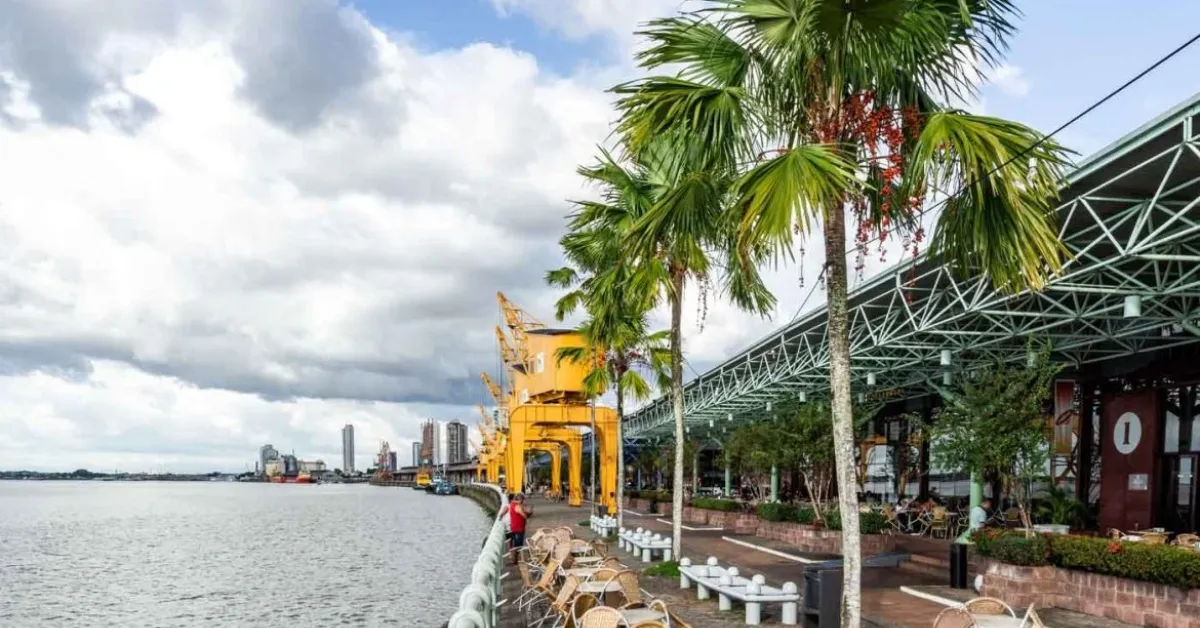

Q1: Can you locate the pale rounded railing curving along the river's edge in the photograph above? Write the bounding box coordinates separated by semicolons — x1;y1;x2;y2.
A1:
446;484;509;628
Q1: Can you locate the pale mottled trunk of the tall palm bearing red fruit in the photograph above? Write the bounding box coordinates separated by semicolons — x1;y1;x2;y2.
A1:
824;204;863;628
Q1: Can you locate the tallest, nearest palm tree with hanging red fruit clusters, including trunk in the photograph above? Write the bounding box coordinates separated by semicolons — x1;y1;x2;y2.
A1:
614;0;1066;627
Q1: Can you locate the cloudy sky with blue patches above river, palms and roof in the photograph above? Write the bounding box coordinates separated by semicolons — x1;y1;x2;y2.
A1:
0;0;1200;472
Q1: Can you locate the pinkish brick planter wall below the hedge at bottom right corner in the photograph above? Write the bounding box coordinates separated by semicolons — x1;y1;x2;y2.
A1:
980;562;1200;628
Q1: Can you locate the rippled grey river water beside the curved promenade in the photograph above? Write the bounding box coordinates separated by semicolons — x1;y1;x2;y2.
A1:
0;482;490;628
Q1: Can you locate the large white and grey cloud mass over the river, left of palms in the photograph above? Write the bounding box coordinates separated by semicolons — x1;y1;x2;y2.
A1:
0;0;611;469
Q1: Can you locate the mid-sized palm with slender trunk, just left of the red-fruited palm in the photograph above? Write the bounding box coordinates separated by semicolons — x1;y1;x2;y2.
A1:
556;143;774;555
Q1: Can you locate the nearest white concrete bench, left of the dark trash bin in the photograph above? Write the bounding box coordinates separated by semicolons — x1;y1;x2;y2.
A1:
679;557;800;626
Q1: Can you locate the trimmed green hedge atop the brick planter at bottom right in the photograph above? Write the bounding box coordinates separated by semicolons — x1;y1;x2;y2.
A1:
971;530;1200;588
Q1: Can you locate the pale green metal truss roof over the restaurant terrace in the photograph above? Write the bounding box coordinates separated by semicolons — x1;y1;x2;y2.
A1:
625;95;1200;437
